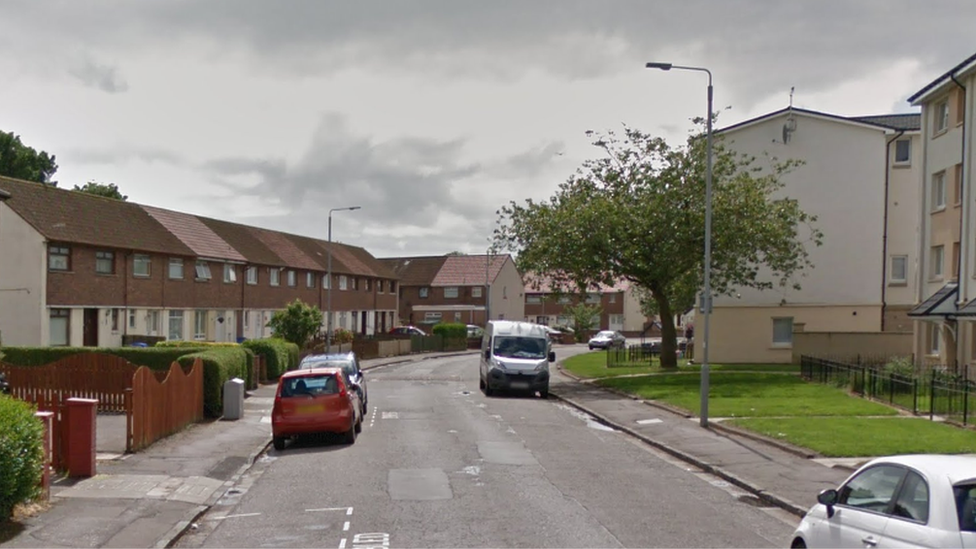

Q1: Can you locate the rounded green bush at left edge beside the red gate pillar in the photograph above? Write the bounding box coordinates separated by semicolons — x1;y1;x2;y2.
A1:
0;395;44;521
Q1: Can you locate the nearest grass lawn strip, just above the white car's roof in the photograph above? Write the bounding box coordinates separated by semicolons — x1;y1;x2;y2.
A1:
723;417;976;457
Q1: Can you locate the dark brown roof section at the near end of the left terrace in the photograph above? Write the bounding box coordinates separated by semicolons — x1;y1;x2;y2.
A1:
0;177;196;256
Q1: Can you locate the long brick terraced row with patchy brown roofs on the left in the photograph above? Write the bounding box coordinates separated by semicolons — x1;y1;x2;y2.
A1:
0;178;398;346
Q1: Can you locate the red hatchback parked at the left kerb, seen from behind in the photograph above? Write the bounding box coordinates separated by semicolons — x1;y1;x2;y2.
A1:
271;368;363;450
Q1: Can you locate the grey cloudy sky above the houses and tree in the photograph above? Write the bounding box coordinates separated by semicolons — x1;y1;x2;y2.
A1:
0;0;976;257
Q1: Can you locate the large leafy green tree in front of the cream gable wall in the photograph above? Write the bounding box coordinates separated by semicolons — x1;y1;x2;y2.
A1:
495;124;822;368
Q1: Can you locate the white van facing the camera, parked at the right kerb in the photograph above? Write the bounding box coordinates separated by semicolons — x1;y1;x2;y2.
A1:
480;320;556;398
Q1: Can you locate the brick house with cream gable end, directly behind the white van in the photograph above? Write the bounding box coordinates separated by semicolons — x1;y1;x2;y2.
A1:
381;254;525;326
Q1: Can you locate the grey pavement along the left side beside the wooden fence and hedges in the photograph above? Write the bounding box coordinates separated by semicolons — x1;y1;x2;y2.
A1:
2;351;477;549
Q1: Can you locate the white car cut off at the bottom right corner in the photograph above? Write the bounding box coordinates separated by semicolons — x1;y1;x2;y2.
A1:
790;455;976;549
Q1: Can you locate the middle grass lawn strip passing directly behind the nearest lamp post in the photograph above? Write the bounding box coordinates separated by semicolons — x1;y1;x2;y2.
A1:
598;371;897;423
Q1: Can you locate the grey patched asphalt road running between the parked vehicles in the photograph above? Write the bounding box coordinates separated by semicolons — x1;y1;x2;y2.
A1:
177;348;796;549
